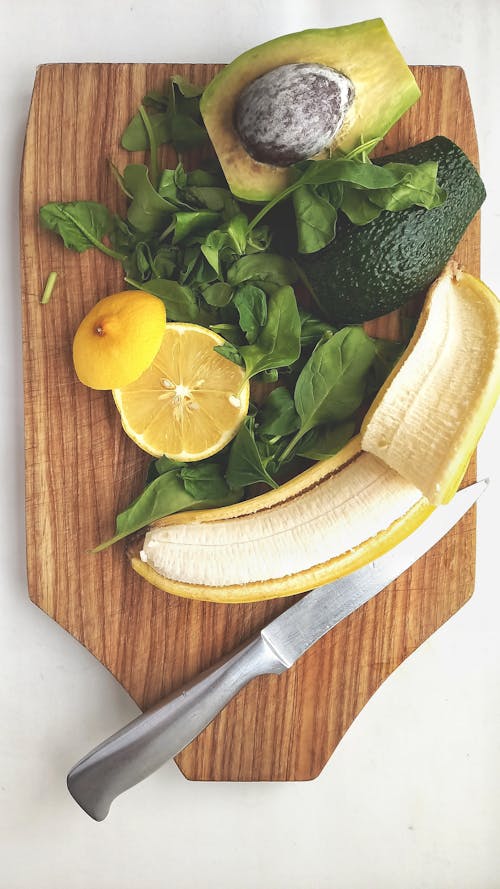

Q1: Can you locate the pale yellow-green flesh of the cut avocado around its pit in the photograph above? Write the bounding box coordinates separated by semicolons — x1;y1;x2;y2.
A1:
200;19;420;202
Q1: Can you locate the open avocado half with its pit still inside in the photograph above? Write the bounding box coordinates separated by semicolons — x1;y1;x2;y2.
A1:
200;19;420;202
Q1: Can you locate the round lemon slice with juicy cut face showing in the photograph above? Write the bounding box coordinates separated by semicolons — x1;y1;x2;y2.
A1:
113;323;250;461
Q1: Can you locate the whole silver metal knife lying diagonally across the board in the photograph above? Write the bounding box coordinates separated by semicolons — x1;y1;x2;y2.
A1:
67;479;488;821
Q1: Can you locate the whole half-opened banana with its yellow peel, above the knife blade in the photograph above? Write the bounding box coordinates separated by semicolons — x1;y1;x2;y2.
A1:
128;263;500;603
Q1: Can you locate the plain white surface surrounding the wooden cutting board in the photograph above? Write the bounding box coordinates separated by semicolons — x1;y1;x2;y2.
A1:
0;0;500;889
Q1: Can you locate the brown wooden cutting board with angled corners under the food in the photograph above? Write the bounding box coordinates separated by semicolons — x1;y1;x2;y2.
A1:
21;64;479;781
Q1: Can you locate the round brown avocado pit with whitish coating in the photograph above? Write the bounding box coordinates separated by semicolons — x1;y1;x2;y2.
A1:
234;63;354;167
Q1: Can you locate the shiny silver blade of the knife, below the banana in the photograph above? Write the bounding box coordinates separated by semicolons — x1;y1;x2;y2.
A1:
261;479;488;667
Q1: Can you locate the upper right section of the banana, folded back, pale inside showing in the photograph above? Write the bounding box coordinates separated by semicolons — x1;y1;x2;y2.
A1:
361;263;500;504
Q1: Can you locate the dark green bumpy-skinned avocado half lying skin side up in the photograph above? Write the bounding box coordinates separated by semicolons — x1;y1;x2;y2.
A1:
298;136;486;324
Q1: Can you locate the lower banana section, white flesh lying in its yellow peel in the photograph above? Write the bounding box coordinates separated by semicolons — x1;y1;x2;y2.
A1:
132;437;432;602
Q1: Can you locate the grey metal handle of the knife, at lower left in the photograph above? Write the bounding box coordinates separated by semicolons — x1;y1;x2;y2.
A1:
67;635;286;821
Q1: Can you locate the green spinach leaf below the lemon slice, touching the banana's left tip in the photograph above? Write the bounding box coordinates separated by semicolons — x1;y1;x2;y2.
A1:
93;465;242;552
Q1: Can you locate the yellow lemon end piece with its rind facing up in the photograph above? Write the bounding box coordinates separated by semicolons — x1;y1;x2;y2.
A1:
73;290;166;389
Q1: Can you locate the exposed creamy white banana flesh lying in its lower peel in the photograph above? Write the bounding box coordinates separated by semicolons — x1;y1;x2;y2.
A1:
141;453;422;586
